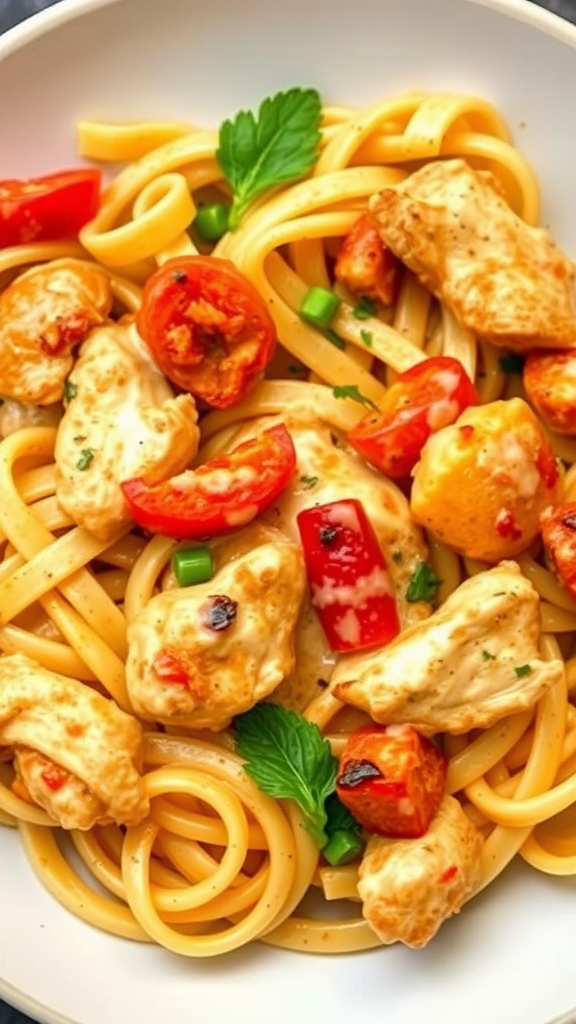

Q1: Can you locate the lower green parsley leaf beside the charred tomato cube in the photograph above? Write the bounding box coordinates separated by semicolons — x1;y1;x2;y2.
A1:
234;702;338;849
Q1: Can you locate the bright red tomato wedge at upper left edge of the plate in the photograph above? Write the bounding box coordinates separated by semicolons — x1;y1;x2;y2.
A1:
0;168;101;249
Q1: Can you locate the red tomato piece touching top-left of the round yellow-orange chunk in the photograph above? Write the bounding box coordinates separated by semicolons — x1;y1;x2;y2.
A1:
347;355;480;479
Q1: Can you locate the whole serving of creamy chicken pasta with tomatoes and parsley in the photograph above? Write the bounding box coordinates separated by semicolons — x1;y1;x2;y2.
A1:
0;88;576;957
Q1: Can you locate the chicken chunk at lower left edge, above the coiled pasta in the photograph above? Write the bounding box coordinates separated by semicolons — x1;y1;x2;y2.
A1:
0;654;149;829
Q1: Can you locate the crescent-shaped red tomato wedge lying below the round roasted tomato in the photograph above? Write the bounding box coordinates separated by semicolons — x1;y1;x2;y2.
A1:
121;424;296;541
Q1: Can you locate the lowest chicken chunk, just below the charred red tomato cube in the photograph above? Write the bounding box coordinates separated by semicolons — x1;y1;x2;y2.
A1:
358;795;483;949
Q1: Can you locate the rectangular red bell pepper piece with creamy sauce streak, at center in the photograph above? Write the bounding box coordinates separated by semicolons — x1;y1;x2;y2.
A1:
297;499;400;651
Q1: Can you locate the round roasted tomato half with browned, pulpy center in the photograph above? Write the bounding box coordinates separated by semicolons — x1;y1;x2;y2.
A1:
136;256;277;409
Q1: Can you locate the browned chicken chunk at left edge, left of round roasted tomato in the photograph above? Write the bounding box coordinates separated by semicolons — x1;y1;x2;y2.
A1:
0;259;112;406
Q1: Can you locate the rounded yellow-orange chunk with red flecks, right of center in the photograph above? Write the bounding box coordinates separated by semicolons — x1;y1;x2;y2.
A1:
410;398;562;563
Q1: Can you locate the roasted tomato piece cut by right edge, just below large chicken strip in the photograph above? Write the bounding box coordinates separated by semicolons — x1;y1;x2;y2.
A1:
522;348;576;437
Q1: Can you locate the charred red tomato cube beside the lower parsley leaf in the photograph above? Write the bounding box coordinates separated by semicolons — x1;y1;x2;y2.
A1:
336;725;447;839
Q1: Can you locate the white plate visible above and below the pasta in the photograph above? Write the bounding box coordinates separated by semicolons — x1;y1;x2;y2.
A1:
0;0;576;1024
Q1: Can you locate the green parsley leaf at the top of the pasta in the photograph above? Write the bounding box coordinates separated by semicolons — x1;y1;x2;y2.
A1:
216;88;322;230
